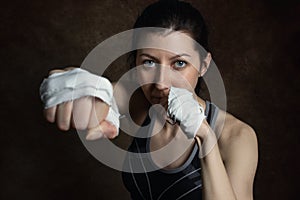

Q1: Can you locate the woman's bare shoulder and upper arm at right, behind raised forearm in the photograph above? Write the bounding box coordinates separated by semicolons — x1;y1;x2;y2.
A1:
216;110;258;199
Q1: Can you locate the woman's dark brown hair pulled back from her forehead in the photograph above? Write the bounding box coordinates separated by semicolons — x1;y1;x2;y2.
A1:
128;0;208;94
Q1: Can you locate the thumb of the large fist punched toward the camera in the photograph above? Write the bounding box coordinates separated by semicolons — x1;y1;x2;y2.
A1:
85;120;118;140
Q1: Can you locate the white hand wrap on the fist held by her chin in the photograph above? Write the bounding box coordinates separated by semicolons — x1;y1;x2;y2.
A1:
167;87;206;138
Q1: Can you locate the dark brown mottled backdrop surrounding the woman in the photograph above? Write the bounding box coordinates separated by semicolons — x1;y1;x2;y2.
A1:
0;0;300;199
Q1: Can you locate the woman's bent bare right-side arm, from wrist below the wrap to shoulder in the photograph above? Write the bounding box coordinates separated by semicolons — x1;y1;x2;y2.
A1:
197;118;258;200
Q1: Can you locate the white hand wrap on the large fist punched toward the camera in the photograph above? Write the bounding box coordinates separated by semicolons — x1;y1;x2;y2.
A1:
40;68;120;130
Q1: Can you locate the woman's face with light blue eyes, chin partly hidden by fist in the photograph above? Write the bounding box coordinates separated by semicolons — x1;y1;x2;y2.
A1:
136;32;210;106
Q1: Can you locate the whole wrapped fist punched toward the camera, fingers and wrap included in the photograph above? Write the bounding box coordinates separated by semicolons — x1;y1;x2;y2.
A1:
40;68;120;140
